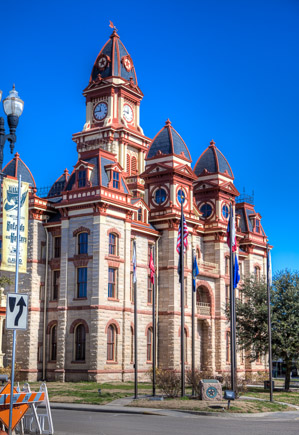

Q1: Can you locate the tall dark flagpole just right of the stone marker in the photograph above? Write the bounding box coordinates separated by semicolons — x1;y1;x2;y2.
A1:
229;204;235;391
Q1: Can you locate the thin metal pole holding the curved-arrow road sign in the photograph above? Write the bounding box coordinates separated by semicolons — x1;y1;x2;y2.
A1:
8;175;21;435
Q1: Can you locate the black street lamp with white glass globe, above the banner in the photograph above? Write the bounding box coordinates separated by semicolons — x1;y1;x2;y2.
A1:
0;85;24;170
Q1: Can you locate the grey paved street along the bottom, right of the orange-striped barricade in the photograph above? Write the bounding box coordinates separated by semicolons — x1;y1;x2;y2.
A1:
52;409;299;435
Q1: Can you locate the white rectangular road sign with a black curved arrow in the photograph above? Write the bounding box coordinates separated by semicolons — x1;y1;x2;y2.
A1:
6;293;28;330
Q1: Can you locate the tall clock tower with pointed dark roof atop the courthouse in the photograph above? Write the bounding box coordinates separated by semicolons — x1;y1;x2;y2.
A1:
73;30;150;196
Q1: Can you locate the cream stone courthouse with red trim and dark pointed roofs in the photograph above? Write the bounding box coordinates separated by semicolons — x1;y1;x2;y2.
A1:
2;30;267;381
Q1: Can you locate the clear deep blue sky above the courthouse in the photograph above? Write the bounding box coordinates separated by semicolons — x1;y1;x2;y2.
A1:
0;0;299;271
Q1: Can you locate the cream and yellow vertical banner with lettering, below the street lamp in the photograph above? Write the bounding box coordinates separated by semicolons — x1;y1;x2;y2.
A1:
1;177;29;273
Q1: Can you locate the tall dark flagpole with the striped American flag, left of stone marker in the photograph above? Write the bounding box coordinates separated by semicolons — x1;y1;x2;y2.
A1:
180;199;185;397
